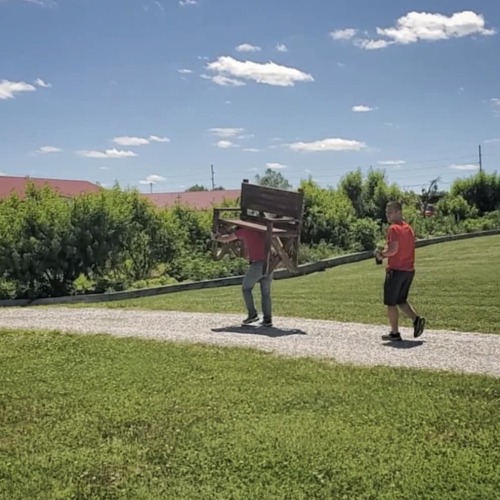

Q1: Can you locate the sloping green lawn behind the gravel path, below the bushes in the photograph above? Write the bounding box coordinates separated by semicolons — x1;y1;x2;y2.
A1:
89;236;500;333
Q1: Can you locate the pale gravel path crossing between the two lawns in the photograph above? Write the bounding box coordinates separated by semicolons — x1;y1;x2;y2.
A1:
0;307;500;377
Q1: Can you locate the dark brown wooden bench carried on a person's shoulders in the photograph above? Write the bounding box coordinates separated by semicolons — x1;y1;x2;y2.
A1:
213;179;304;273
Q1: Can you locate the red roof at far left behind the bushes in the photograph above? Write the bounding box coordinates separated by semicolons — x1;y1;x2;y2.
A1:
0;175;102;198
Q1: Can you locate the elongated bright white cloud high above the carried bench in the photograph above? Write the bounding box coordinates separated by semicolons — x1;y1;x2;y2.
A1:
207;56;314;87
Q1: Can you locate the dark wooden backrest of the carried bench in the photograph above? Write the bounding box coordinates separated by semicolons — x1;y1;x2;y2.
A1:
240;182;304;221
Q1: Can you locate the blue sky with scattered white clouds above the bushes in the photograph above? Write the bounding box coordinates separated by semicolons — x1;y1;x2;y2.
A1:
0;0;500;192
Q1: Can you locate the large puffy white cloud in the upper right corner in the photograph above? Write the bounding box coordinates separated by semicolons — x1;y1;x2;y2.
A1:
354;10;496;50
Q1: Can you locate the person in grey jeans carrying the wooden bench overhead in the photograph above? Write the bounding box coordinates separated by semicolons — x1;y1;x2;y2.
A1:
216;227;273;327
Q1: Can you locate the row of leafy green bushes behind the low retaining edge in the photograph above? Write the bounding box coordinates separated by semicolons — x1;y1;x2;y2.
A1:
0;171;500;298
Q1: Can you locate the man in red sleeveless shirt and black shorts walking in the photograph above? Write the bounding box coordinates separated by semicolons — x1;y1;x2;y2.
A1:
376;201;425;341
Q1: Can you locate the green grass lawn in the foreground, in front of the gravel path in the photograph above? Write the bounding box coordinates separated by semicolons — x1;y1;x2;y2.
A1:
0;330;500;500
